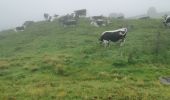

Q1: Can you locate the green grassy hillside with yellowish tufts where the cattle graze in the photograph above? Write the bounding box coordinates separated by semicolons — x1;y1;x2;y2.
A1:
0;19;170;100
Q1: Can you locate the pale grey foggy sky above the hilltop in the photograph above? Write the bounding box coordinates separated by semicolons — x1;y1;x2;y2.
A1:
0;0;170;30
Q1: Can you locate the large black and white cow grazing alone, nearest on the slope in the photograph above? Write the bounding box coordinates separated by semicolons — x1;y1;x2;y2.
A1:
99;28;127;47
